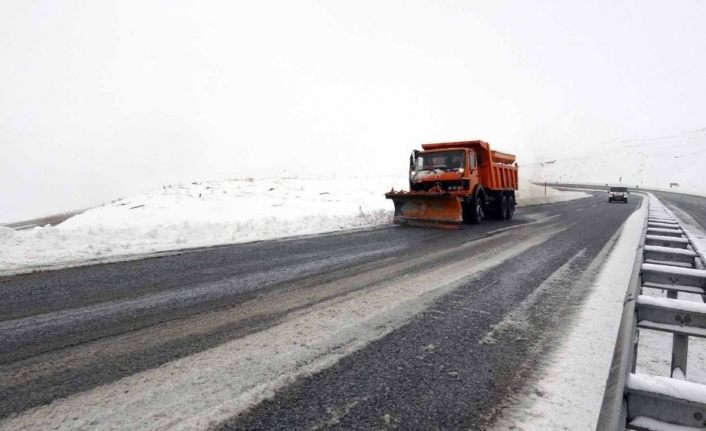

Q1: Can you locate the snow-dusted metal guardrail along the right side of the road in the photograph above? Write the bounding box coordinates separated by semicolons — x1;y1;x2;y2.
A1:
596;195;706;431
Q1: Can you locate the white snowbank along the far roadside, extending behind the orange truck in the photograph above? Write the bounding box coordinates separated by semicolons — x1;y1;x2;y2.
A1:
0;175;587;275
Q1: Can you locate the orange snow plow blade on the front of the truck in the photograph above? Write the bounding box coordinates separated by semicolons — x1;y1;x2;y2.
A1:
385;192;463;229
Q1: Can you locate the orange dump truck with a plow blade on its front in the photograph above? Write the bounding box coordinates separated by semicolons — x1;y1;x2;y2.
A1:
385;141;517;228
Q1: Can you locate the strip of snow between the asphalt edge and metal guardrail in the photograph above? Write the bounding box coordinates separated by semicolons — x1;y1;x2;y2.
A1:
495;194;647;431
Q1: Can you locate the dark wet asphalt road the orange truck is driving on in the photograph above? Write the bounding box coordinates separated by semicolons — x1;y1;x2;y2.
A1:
0;194;639;430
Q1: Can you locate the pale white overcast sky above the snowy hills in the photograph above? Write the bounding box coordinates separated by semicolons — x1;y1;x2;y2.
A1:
0;0;706;222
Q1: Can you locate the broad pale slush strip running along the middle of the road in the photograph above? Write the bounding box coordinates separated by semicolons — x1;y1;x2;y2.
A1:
0;227;567;430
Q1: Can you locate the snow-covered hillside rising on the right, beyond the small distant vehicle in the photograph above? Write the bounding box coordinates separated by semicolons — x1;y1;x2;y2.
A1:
522;129;706;195
